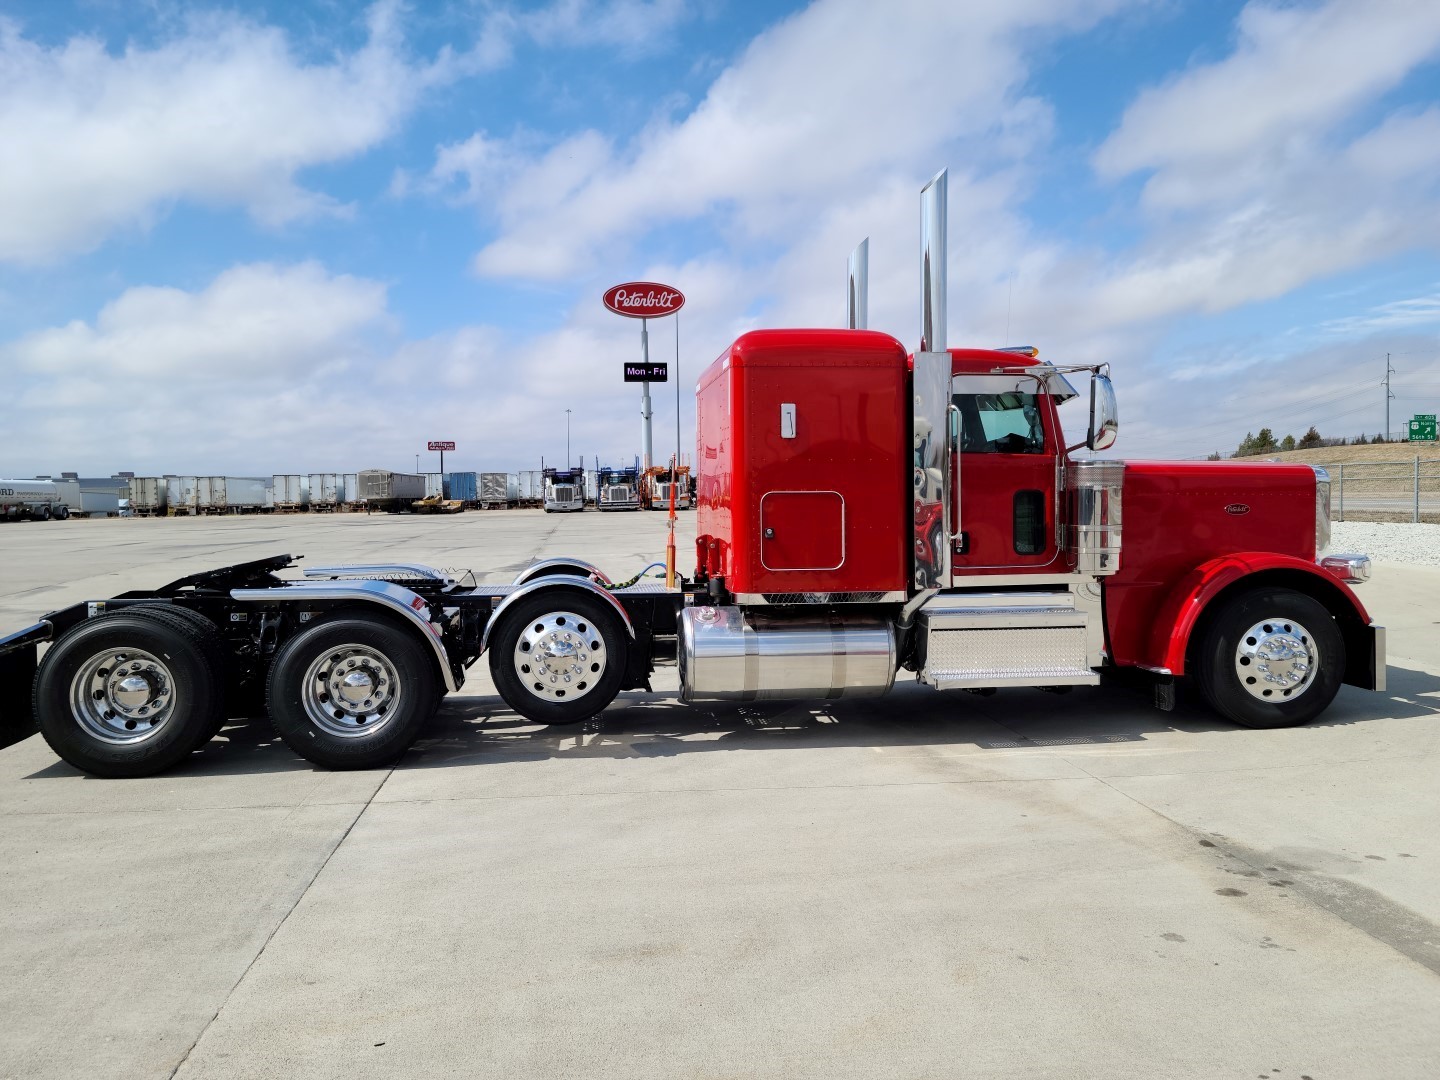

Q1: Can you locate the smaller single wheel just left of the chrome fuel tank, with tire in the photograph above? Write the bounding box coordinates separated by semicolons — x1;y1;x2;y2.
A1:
490;588;629;724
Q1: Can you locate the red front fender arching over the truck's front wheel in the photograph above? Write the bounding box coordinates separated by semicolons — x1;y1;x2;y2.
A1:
1146;552;1369;675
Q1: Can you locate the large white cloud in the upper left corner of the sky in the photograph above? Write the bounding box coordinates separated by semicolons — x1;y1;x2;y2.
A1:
0;3;455;264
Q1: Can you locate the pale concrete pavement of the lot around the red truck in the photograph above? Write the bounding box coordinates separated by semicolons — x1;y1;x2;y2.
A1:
0;513;1440;1080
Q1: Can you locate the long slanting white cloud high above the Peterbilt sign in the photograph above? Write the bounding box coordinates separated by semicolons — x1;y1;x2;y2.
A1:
431;0;1126;279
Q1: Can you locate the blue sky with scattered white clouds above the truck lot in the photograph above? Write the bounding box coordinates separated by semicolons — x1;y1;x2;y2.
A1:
0;0;1440;477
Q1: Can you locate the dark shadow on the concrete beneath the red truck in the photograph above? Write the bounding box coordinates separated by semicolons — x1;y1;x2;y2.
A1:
26;667;1440;779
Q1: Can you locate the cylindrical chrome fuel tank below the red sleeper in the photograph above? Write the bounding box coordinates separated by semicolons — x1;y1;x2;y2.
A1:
680;606;897;701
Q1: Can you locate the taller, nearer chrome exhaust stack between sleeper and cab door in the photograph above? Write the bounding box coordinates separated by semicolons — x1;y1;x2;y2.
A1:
910;168;953;592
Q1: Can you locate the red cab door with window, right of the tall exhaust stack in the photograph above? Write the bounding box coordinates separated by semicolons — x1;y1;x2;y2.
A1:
950;374;1064;579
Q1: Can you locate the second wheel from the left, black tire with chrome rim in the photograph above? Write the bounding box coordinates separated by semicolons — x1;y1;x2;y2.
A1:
265;615;442;769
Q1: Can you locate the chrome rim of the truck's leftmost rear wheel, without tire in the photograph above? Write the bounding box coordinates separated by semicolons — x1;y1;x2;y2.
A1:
71;648;176;746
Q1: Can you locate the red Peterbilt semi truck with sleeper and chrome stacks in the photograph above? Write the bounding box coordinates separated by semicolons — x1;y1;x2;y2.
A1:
0;173;1385;776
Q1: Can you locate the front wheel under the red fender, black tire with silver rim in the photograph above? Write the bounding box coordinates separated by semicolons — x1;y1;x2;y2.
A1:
1195;589;1345;727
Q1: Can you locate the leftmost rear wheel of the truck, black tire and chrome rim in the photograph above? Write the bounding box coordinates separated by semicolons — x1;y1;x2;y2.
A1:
33;611;225;778
